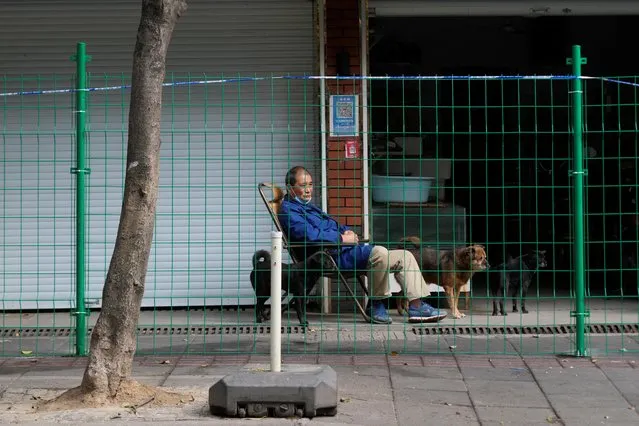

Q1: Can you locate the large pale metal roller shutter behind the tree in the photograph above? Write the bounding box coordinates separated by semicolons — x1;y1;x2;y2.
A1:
0;0;319;309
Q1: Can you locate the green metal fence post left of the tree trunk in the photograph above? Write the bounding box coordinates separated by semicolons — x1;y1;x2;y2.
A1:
71;42;91;356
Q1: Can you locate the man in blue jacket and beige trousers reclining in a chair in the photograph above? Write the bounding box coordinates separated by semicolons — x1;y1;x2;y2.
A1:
278;166;446;324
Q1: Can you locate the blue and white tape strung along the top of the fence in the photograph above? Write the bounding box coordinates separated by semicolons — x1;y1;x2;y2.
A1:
0;75;639;98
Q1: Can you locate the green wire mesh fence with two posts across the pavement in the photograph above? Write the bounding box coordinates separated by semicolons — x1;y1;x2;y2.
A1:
0;44;639;359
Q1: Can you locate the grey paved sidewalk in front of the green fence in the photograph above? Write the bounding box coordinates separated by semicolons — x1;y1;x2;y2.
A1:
0;354;639;426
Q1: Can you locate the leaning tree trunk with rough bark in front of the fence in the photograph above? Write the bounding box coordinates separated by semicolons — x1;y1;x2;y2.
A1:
43;0;187;405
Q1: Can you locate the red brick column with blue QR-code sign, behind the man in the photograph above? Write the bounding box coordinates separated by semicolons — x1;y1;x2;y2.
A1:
325;0;364;227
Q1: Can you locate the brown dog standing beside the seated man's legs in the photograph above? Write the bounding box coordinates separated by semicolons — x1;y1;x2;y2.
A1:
397;236;489;318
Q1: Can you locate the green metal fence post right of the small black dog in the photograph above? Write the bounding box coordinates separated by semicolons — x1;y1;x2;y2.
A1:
567;45;588;356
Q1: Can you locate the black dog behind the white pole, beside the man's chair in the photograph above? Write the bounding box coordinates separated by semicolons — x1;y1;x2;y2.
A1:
251;250;333;327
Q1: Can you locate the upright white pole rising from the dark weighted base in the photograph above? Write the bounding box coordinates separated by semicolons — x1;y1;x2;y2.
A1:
271;231;282;372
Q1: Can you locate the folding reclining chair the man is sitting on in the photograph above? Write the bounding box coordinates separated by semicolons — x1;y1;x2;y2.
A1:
258;182;371;322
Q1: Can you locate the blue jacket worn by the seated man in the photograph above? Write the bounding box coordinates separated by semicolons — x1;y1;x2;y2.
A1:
278;195;373;270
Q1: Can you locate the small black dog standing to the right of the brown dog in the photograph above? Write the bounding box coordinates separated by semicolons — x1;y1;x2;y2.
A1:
489;250;547;316
